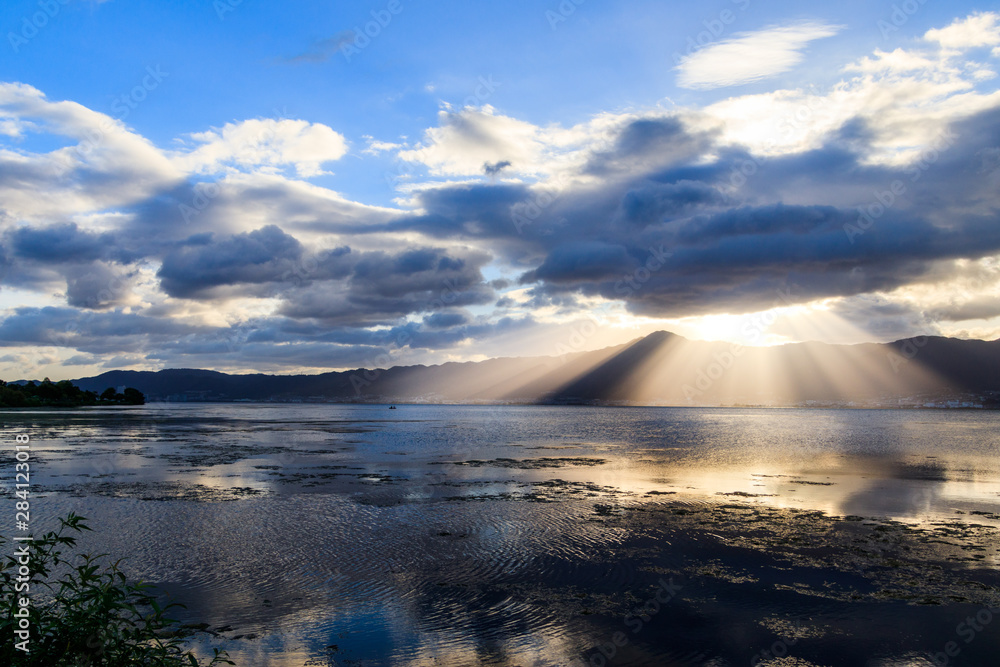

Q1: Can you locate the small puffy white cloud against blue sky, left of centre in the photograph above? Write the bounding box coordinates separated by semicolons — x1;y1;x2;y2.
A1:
178;119;347;178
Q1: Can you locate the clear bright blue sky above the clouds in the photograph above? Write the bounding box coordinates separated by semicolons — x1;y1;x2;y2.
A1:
0;0;975;204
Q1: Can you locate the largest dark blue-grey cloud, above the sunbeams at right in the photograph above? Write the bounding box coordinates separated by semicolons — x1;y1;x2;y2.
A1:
393;111;1000;316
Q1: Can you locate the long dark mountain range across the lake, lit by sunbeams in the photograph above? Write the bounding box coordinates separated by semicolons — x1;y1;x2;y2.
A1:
73;331;1000;407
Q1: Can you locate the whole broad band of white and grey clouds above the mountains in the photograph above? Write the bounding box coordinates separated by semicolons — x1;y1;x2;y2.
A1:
0;15;1000;378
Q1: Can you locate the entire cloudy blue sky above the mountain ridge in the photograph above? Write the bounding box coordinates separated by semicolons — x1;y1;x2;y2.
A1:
0;0;1000;380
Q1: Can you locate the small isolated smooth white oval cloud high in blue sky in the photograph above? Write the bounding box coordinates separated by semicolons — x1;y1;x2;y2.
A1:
677;21;841;89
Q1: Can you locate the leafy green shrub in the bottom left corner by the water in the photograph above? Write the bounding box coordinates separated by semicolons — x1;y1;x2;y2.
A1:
0;513;235;667
